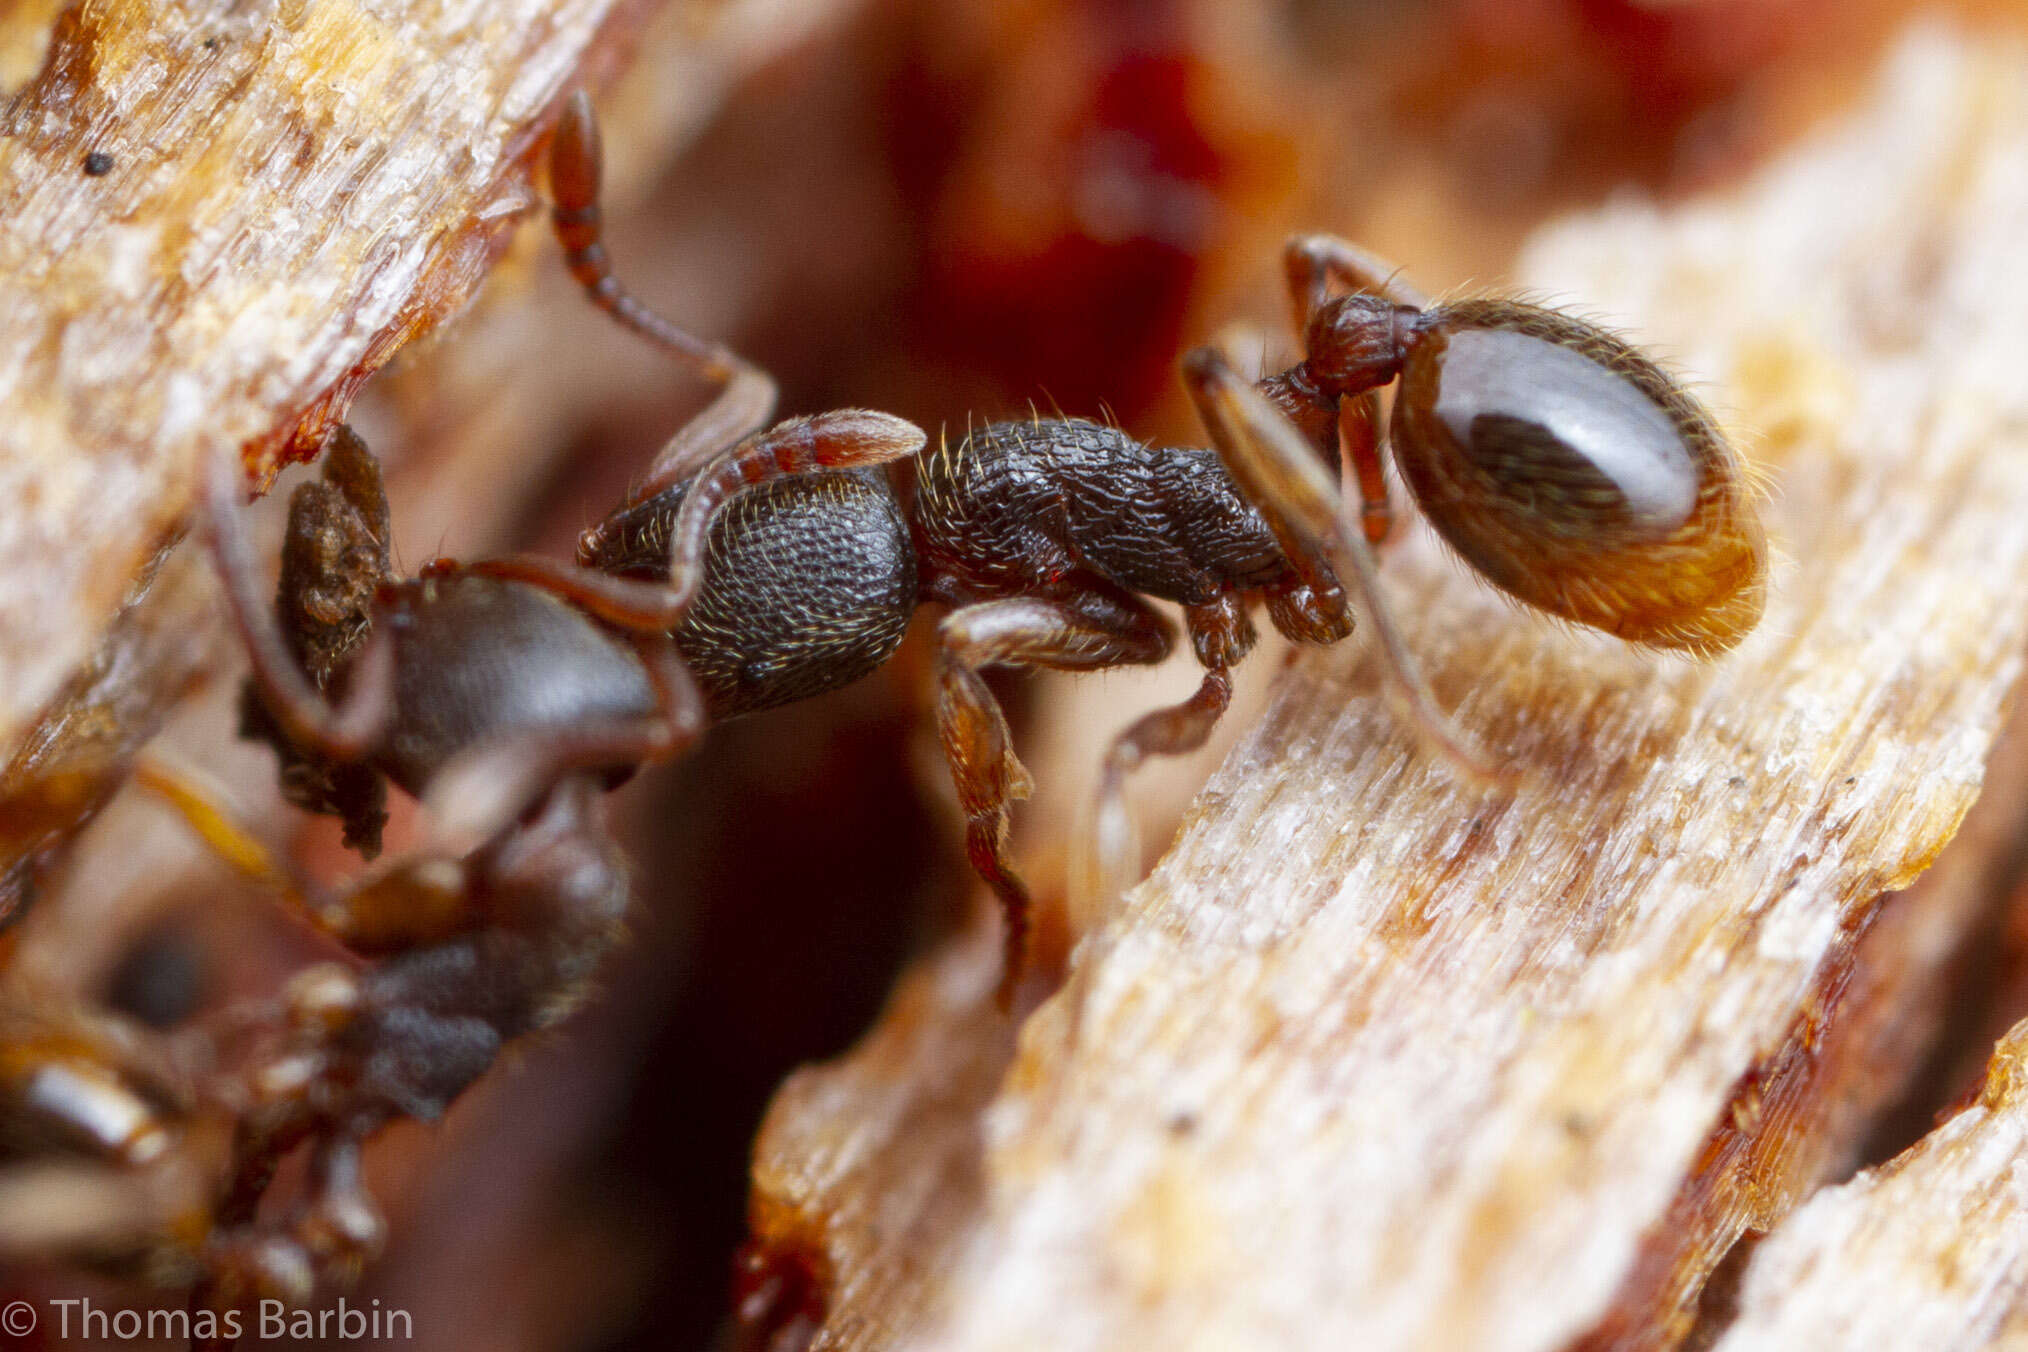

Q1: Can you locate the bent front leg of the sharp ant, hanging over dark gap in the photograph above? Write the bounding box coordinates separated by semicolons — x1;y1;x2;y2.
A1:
937;588;1170;1009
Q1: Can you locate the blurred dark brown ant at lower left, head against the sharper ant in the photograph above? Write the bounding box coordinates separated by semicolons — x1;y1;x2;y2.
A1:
142;411;923;1307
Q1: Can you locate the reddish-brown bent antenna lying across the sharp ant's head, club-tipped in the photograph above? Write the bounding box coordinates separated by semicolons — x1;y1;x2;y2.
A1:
547;409;927;632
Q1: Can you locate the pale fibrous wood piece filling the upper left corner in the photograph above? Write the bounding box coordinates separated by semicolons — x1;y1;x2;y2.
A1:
0;0;649;754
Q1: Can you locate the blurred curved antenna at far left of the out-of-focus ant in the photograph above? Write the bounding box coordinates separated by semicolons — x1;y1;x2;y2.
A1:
205;446;393;762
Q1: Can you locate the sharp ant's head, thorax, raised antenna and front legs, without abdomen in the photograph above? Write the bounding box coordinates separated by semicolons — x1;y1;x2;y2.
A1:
523;95;1351;1003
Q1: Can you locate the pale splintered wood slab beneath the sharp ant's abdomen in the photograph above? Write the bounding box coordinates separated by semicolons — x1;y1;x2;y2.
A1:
752;30;2028;1352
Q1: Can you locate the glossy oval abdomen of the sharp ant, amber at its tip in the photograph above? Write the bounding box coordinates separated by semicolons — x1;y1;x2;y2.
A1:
1391;300;1766;655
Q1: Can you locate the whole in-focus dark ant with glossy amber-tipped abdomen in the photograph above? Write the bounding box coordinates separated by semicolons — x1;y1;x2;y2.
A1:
527;95;1766;1003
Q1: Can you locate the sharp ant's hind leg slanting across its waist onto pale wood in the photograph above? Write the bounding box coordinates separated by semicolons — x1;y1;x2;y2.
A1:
1182;347;1511;786
